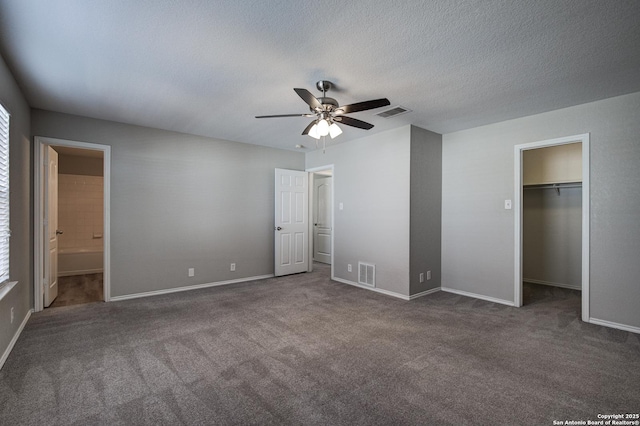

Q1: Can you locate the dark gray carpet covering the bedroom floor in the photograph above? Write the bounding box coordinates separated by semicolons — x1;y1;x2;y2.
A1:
0;265;640;425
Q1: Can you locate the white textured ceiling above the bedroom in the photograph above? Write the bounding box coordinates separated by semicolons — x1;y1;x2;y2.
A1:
0;0;640;149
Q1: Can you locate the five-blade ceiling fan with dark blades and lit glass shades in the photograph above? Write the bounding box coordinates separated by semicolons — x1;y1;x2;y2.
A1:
256;80;390;139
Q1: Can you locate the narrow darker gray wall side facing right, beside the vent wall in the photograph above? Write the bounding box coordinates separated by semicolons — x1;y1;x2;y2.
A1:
409;126;442;295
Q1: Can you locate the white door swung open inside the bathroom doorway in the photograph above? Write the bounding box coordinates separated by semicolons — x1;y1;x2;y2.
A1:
43;146;62;308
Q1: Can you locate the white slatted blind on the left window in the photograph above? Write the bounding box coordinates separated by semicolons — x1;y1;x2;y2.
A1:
0;101;11;287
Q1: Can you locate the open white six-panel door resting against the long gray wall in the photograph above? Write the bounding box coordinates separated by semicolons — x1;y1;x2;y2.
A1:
274;169;309;276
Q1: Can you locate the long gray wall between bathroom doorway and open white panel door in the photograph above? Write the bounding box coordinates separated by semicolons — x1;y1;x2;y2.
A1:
32;110;304;296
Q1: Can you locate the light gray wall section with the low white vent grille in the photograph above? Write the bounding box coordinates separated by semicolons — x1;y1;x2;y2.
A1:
306;126;411;296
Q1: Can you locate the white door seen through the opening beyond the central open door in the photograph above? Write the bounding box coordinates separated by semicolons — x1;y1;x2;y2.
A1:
313;176;333;264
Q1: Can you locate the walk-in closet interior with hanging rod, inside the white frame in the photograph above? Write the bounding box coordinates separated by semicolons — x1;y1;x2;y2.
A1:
522;143;582;307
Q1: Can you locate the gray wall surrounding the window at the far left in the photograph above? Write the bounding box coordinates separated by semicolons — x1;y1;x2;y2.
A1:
0;58;33;362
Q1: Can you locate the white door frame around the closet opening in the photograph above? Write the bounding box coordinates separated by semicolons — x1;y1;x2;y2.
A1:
514;133;591;322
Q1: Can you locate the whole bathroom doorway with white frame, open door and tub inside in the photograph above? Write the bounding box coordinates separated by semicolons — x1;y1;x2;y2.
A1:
34;137;111;312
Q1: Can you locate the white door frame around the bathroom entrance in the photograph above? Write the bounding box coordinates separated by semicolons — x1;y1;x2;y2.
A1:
33;136;111;312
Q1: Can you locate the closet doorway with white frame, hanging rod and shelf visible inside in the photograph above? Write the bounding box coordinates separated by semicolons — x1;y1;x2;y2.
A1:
514;134;589;321
